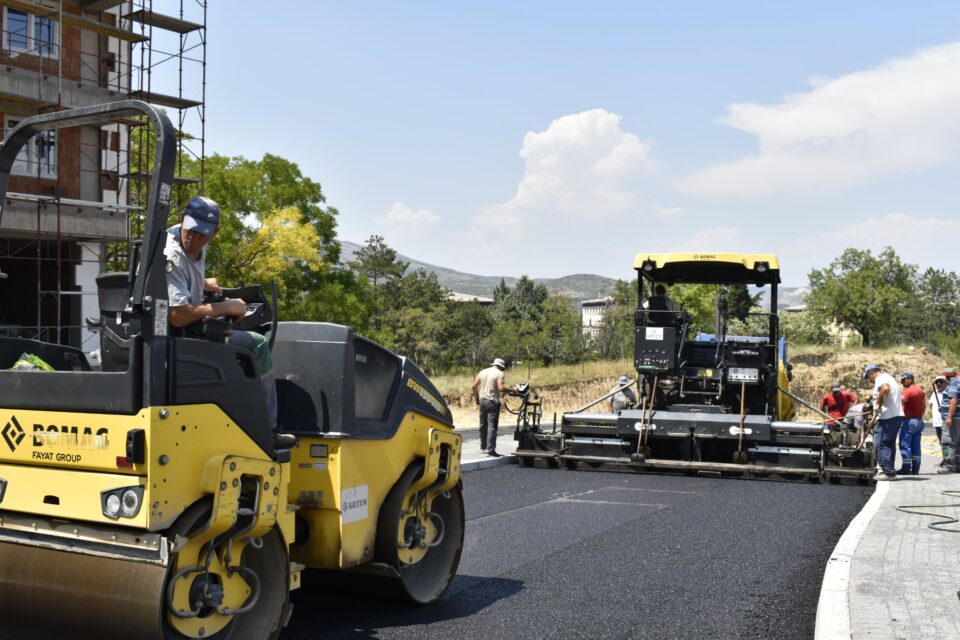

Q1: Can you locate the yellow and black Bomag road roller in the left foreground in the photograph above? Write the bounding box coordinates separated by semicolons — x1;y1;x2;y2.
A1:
0;101;464;640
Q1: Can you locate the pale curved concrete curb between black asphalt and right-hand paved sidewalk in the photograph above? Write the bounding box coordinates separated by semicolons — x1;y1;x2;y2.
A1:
813;482;890;640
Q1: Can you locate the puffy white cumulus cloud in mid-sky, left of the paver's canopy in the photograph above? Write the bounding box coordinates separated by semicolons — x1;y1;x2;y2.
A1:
473;109;656;235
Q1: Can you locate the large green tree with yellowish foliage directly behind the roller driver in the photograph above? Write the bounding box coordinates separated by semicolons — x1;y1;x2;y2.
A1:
171;153;370;330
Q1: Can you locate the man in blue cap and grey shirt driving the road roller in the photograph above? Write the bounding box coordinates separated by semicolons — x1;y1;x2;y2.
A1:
163;196;296;448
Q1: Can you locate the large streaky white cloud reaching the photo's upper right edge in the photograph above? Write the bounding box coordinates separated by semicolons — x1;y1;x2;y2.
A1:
677;43;960;197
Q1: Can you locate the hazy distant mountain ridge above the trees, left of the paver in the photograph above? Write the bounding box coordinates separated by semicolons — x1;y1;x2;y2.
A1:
340;240;616;301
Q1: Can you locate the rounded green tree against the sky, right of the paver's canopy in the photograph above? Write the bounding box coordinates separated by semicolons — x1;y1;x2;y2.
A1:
807;247;916;346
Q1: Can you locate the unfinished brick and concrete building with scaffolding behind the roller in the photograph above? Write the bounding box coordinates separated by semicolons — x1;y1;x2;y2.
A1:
0;0;207;351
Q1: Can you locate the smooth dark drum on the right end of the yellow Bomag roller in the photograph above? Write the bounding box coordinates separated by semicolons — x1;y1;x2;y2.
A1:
375;460;465;604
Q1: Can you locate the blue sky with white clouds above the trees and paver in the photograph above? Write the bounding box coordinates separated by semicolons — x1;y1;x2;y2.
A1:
195;0;960;285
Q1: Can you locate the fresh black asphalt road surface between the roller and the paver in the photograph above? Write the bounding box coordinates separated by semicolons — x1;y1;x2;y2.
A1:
281;465;872;640
